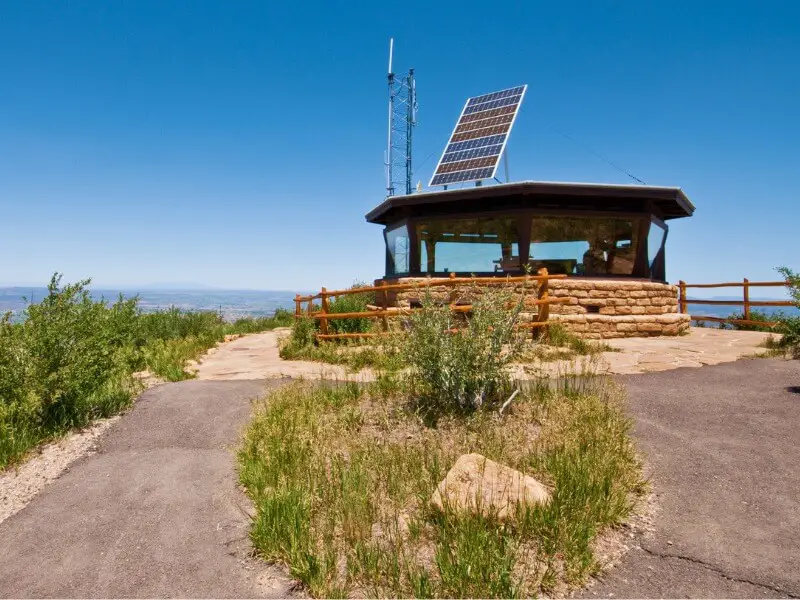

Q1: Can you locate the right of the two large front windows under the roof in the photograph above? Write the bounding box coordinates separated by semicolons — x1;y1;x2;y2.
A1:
529;216;638;275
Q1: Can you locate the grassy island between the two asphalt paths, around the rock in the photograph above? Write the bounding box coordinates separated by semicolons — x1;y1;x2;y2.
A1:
238;380;643;597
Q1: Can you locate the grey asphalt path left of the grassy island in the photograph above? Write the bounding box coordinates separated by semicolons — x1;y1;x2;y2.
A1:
0;381;290;598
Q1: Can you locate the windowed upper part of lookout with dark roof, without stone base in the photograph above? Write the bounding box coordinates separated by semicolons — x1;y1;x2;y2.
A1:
366;181;694;281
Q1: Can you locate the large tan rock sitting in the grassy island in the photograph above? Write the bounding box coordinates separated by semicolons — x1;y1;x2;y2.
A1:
431;454;550;520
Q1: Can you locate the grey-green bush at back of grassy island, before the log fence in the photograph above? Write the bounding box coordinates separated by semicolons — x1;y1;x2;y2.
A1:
403;290;524;413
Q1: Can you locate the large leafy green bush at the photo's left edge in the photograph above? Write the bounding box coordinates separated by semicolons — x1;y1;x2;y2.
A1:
0;275;139;468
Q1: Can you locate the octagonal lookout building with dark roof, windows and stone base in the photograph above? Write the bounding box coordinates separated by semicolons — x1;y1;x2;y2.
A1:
366;181;694;338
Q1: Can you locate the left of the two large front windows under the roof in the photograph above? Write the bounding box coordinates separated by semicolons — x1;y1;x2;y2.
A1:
417;218;520;274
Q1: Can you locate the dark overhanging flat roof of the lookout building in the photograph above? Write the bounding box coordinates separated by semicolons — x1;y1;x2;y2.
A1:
366;181;695;223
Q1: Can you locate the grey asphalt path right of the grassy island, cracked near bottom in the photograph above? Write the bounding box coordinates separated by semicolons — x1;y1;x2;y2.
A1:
582;359;800;598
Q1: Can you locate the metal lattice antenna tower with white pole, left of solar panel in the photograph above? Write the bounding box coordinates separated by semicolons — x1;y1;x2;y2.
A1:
384;38;417;196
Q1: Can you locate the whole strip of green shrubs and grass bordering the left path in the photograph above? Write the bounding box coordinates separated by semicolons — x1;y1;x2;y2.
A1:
0;274;292;469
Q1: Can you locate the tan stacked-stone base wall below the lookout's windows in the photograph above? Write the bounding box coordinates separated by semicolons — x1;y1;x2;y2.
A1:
376;277;691;339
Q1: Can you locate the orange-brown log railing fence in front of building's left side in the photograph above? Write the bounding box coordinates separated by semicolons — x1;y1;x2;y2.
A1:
294;269;570;340
